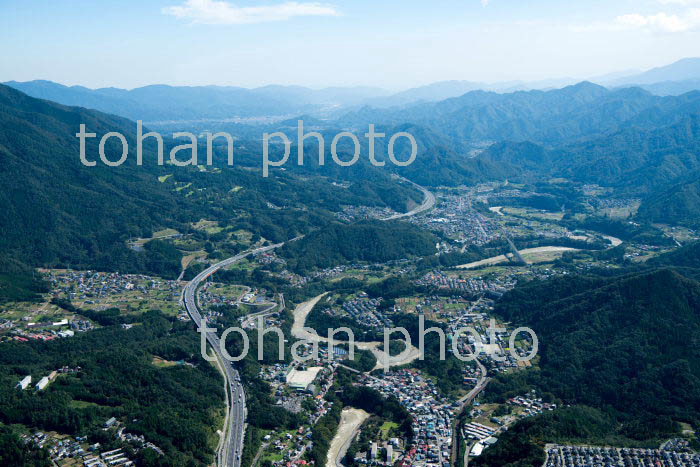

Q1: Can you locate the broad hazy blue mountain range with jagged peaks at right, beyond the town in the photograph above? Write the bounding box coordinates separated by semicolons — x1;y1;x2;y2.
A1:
336;82;700;202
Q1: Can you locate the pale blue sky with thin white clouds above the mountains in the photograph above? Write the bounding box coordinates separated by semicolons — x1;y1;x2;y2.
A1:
0;0;700;91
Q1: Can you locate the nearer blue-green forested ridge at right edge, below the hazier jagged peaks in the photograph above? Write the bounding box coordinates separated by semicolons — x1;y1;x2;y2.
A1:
477;113;700;227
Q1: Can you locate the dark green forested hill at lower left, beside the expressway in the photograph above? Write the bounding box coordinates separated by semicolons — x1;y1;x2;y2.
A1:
0;311;223;466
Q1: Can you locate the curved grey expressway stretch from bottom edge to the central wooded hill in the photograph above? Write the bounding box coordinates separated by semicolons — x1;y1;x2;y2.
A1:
183;243;283;467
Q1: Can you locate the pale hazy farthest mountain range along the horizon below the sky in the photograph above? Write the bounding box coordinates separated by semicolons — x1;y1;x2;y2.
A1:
4;58;700;122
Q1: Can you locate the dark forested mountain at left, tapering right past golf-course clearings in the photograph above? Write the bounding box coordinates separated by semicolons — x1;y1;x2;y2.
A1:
0;85;421;282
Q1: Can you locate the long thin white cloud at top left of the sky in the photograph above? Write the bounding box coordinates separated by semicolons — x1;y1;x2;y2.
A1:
163;0;339;24
